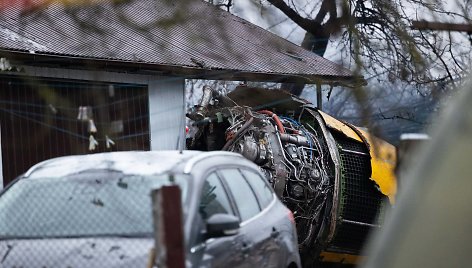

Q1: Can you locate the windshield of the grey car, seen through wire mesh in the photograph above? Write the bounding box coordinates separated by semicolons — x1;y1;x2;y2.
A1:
0;170;188;239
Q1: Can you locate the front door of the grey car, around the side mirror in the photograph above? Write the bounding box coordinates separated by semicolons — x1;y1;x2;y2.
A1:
191;172;249;268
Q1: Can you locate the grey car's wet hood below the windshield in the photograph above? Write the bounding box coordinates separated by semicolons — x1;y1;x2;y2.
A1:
0;238;154;268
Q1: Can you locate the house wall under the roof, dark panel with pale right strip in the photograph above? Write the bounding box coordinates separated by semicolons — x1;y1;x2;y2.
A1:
0;66;185;184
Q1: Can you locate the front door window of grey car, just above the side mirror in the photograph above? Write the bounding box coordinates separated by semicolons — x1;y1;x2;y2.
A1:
199;173;234;220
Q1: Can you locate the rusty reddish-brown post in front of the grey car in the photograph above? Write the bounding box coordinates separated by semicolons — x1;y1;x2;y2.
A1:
151;185;185;268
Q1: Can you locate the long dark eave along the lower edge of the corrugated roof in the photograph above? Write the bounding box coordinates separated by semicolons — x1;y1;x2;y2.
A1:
0;49;365;87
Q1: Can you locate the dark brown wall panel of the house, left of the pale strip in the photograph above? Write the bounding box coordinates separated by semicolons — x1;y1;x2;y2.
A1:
0;76;150;184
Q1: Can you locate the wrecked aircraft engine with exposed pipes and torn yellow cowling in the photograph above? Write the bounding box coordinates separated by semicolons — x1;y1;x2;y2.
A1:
187;86;396;264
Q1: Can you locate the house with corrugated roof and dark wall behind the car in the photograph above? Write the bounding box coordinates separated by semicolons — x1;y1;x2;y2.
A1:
0;0;353;185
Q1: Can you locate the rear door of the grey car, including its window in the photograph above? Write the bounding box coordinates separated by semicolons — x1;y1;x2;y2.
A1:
219;168;280;267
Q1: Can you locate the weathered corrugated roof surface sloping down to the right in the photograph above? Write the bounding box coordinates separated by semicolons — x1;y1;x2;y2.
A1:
0;0;352;80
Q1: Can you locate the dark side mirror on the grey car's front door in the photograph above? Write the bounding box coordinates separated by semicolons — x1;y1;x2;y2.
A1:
206;213;239;238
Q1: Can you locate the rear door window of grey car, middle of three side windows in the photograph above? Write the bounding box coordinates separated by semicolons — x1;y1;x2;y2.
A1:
221;169;261;221
